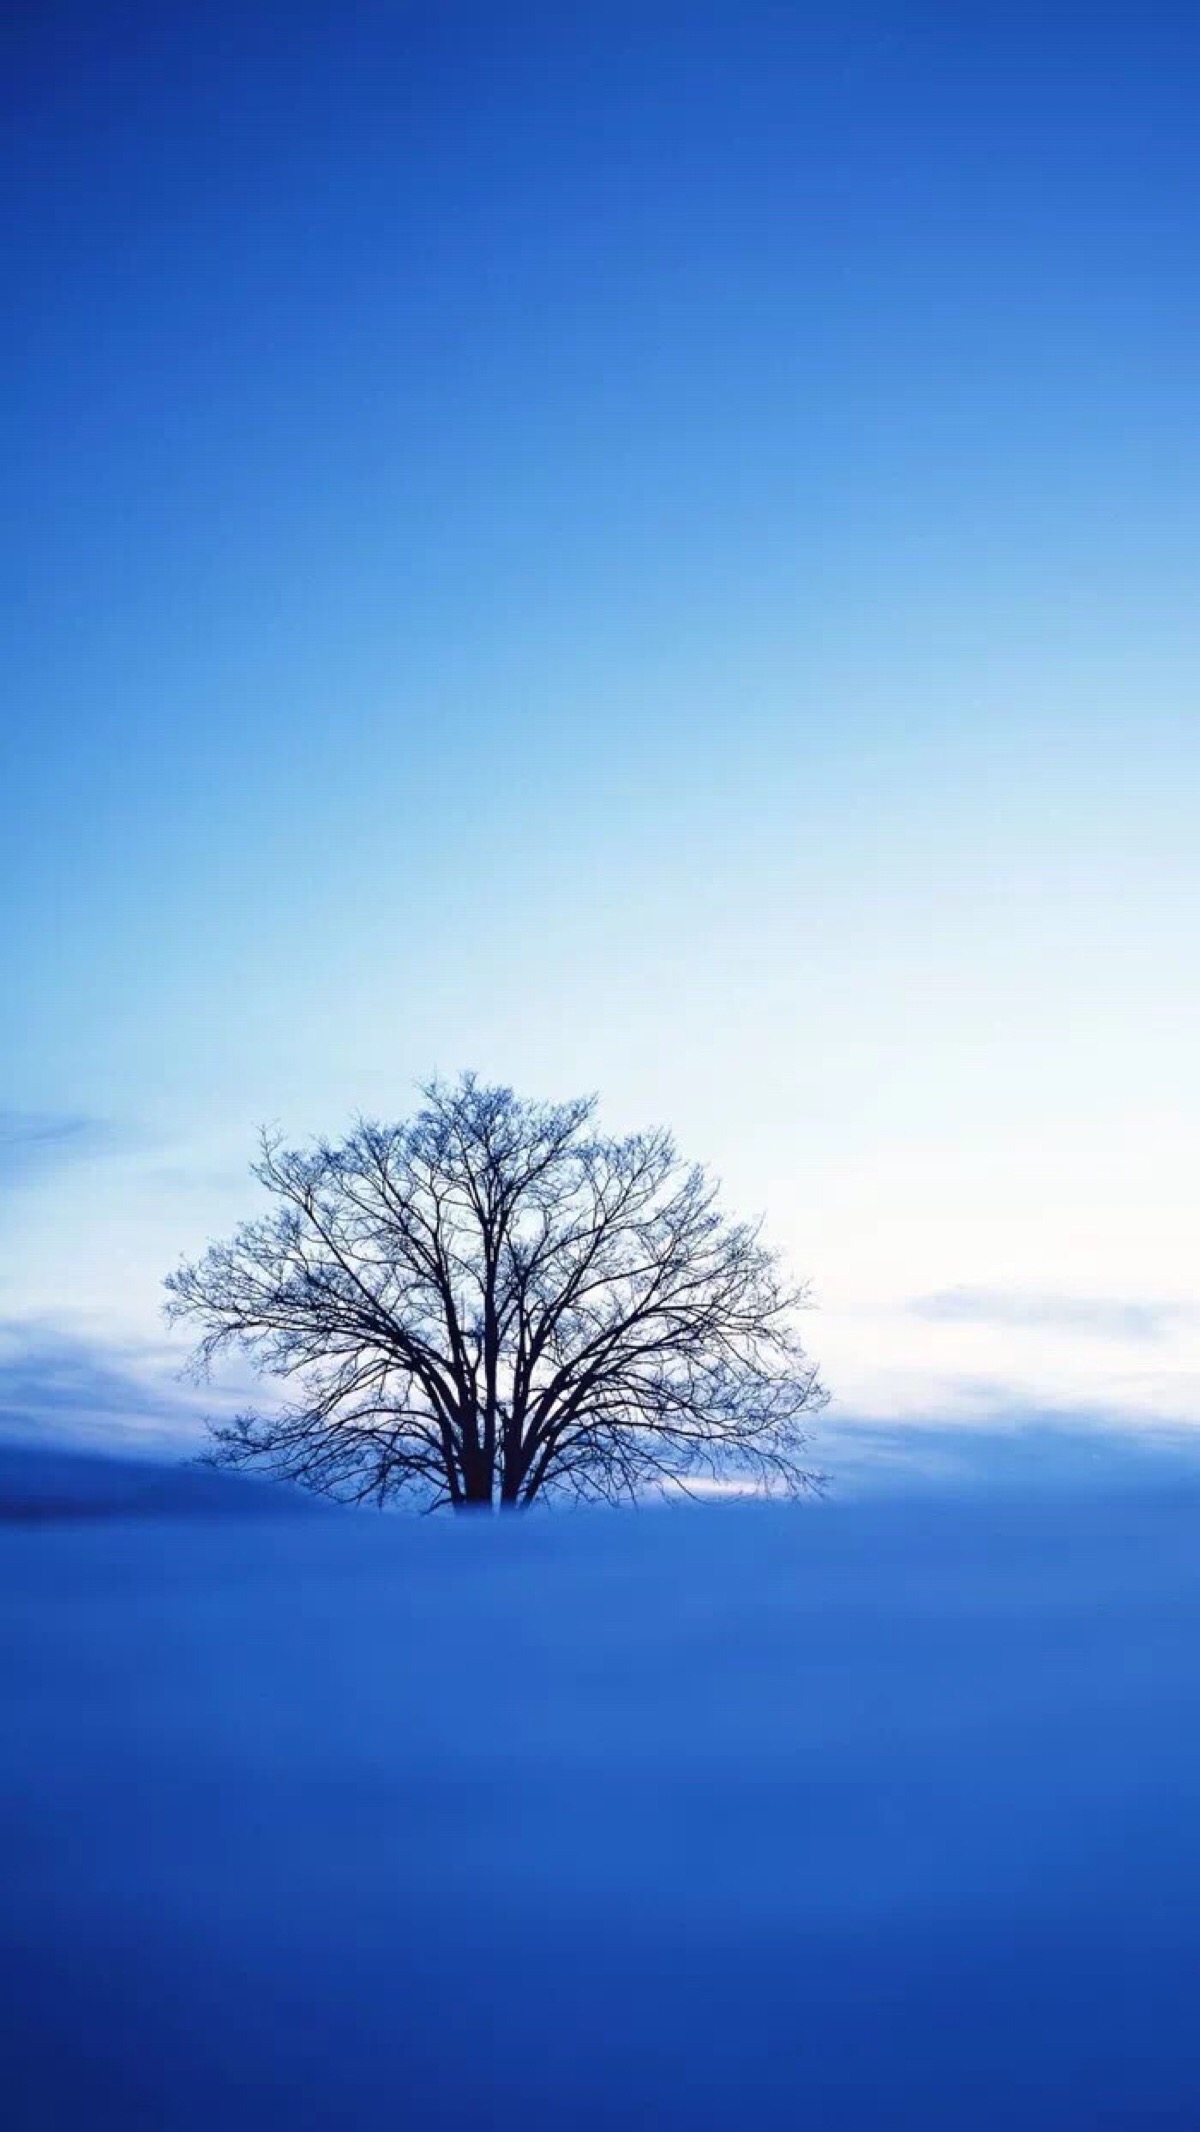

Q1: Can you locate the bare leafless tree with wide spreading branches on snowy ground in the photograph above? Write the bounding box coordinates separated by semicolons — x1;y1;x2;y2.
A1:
166;1075;825;1507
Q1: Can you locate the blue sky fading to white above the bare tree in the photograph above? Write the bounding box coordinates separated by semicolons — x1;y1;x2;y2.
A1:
0;0;1200;1449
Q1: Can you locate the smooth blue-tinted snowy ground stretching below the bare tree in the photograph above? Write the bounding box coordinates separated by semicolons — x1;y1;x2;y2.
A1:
0;1454;1200;2132
